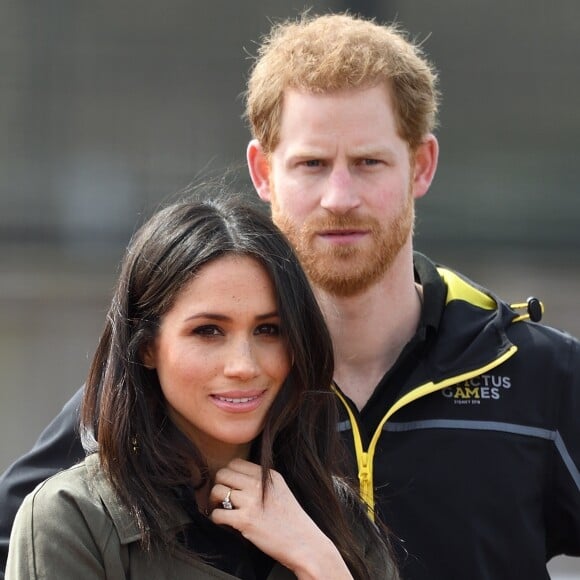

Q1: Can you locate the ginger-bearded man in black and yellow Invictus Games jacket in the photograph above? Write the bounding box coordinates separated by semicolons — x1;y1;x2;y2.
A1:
1;15;580;580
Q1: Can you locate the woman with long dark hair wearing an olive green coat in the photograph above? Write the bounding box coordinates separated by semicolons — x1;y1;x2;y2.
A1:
7;196;396;580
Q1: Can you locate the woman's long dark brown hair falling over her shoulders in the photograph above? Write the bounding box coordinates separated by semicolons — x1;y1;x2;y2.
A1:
82;193;392;578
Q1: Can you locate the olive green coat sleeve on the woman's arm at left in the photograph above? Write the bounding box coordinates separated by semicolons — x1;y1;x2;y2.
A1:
6;464;119;580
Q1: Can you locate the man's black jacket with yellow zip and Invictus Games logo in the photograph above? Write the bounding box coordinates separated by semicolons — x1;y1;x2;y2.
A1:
0;255;580;580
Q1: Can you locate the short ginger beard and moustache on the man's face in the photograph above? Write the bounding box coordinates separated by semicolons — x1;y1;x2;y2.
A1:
272;192;415;297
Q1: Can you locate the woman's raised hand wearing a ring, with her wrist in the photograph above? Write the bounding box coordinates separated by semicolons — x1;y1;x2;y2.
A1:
210;459;352;580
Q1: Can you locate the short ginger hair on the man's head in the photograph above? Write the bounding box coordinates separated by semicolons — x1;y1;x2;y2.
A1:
245;13;439;154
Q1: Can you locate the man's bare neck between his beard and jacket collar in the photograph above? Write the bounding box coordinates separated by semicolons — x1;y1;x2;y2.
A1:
317;255;421;409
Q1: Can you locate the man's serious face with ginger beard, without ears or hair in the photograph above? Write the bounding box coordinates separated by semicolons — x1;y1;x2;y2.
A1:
262;86;414;296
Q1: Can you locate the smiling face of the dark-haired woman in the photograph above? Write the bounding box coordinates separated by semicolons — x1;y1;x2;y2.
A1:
144;256;291;458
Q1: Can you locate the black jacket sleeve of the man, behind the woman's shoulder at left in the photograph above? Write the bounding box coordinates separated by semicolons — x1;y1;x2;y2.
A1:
0;389;85;580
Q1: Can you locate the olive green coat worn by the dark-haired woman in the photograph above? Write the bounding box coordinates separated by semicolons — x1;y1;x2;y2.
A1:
6;455;295;580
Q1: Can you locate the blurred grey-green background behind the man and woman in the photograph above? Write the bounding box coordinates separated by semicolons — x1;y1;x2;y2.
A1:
0;0;580;578
